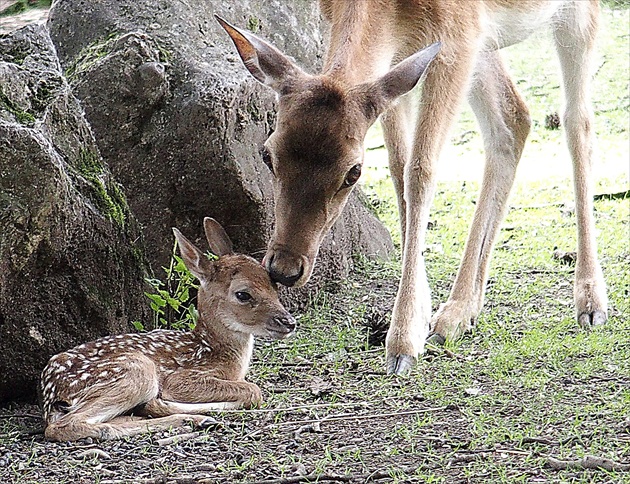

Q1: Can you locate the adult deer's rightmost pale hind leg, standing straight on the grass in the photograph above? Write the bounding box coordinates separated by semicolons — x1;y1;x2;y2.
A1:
554;2;608;328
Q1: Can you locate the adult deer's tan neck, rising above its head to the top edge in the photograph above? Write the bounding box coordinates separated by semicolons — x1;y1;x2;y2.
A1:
323;1;395;87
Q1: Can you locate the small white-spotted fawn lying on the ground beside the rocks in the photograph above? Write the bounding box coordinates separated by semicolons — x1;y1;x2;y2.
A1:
41;218;295;440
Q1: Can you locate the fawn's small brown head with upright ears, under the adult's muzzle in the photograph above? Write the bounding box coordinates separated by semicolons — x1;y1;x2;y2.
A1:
173;218;295;339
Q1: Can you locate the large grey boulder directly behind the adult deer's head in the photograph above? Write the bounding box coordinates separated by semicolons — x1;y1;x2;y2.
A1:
49;0;391;298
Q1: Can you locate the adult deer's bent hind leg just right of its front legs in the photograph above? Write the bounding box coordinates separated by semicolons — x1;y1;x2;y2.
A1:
430;51;530;343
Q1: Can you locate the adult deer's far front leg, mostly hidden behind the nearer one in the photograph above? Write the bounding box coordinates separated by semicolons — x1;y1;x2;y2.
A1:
381;94;413;247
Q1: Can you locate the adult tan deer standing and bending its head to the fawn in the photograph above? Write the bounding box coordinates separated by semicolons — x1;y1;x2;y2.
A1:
219;0;607;374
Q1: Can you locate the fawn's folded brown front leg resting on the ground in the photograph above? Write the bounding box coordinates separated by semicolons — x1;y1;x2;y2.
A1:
159;370;262;413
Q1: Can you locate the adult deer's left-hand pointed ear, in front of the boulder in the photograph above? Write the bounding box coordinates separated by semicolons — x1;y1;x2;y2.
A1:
214;15;305;93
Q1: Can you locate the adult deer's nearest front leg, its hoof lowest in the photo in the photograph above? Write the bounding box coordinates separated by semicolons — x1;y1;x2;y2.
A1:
385;49;475;374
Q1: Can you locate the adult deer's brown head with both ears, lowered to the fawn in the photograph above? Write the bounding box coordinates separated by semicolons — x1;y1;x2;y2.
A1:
217;17;440;287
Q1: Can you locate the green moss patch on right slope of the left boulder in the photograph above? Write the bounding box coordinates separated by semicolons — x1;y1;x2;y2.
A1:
77;149;129;227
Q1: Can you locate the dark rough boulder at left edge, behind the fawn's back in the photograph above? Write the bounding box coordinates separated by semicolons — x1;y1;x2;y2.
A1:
0;27;149;402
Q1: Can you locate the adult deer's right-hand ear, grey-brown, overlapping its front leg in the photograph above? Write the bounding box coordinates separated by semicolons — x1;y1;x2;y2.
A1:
356;42;442;120
